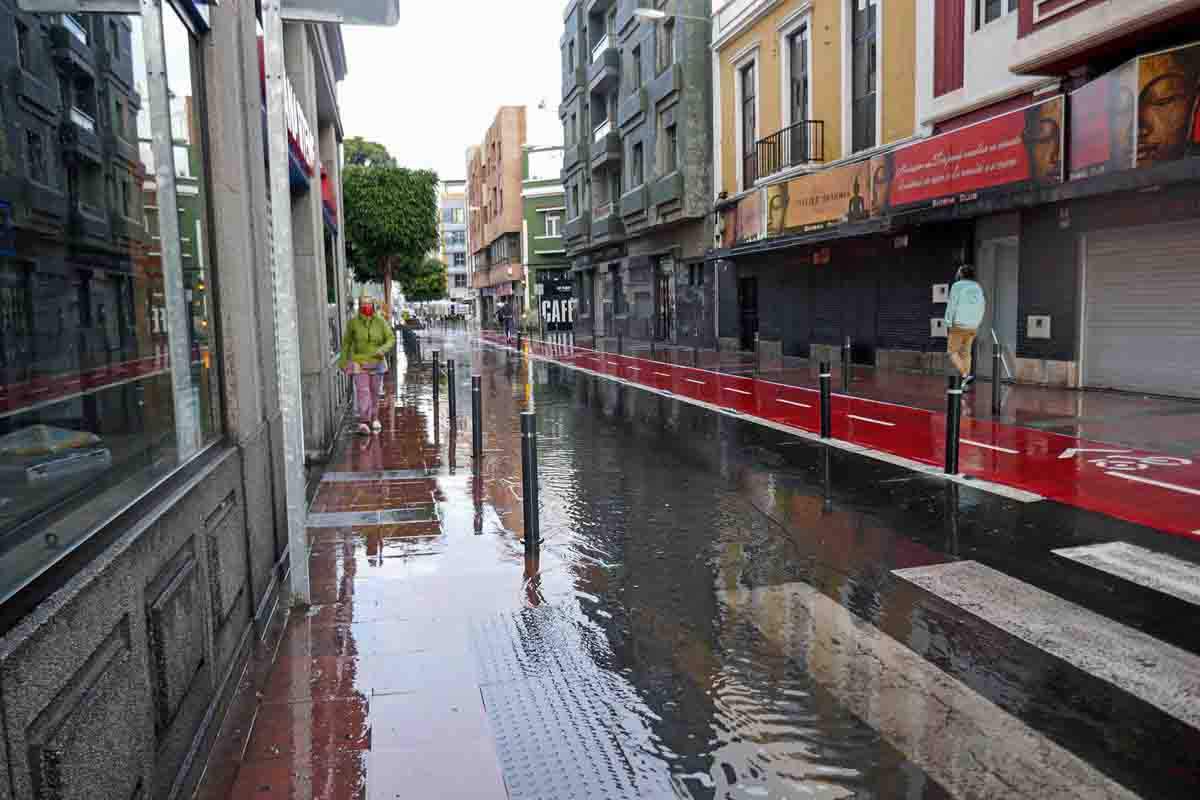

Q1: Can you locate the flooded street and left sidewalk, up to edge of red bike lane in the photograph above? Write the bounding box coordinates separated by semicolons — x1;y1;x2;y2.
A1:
198;335;1200;800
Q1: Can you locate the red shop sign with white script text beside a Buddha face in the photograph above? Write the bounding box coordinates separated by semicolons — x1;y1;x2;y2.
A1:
871;96;1063;215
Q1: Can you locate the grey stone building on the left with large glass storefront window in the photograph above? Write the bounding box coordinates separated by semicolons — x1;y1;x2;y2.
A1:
0;0;349;799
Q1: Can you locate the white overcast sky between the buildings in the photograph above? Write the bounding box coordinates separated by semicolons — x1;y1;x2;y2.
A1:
340;0;565;180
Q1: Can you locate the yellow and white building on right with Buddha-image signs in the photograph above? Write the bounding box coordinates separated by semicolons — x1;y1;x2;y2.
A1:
713;0;1200;397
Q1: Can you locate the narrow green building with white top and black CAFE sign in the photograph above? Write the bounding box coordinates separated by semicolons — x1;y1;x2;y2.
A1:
521;145;575;332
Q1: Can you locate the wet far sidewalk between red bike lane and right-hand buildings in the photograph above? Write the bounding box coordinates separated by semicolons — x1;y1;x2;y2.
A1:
568;336;1200;457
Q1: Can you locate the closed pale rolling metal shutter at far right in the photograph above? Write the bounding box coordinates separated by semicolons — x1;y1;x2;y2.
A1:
1084;222;1200;397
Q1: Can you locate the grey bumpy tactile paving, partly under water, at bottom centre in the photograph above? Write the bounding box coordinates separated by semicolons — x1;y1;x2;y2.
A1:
472;607;677;800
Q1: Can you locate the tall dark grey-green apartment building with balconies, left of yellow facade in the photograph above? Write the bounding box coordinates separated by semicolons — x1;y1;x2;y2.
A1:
559;0;718;345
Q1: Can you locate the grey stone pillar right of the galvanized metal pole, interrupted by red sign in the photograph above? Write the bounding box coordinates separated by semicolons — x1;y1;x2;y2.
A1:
283;23;332;458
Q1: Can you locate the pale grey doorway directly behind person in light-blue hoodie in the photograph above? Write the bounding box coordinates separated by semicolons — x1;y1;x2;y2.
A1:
976;236;1021;378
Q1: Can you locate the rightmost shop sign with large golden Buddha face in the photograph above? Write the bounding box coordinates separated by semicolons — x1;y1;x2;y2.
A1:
1070;43;1200;180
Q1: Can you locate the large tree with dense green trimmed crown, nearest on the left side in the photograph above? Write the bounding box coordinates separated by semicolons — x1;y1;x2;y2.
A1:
342;164;438;305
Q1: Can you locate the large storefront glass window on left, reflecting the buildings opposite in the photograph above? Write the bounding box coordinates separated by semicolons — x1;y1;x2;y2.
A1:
0;9;220;602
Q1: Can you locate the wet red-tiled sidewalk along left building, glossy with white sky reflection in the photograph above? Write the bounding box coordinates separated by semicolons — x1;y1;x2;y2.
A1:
197;357;523;800
